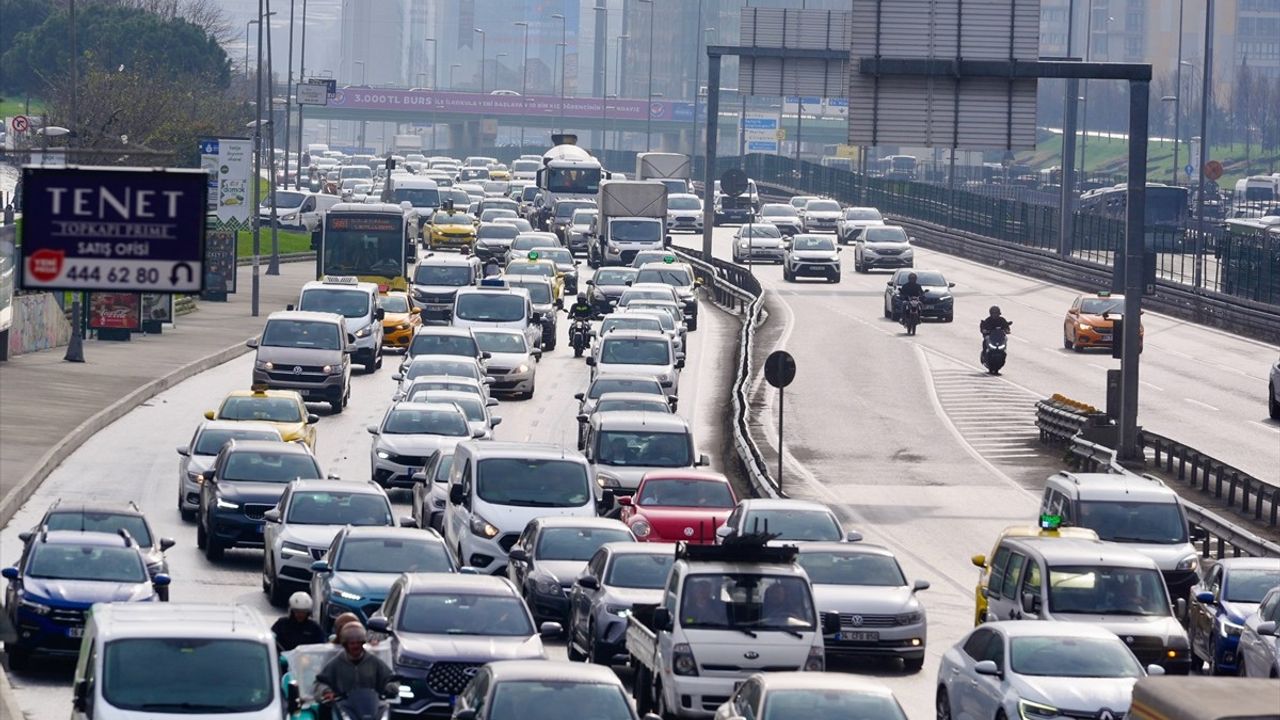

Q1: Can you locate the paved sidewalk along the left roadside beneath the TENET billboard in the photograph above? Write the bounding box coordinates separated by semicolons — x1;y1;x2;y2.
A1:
0;261;315;525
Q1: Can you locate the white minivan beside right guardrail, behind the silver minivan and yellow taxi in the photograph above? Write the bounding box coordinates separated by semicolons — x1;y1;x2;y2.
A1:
1041;471;1201;600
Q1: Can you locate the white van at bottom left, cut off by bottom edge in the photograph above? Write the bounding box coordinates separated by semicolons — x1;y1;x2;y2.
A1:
72;602;288;720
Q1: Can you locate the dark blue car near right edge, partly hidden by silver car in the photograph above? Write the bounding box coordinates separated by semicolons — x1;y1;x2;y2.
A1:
1187;557;1280;675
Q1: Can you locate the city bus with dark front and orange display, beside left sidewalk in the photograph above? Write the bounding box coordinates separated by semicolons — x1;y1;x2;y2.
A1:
316;202;417;292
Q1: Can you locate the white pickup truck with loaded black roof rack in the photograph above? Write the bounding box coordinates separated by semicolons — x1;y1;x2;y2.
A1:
626;536;838;717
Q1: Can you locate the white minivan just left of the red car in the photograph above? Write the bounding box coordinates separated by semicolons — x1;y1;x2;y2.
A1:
443;441;601;575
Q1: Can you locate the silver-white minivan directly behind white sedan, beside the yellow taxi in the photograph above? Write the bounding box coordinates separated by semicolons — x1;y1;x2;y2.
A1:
986;537;1190;675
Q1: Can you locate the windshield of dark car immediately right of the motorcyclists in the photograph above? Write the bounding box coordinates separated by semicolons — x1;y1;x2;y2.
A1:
396;592;534;638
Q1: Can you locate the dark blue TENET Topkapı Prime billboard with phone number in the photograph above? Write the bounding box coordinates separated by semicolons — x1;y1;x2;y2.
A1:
22;168;209;293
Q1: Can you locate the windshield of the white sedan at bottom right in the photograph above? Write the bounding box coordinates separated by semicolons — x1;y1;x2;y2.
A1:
1009;635;1142;678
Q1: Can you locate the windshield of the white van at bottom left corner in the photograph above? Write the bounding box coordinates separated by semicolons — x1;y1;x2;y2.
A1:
101;638;278;716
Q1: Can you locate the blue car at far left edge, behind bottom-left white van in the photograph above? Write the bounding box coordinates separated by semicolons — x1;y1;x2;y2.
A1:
3;530;169;670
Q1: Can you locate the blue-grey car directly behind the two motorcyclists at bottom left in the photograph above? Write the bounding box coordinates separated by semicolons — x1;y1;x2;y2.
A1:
311;525;458;629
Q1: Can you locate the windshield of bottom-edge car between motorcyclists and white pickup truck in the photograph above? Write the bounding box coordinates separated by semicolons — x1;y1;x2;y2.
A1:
485;680;635;720
